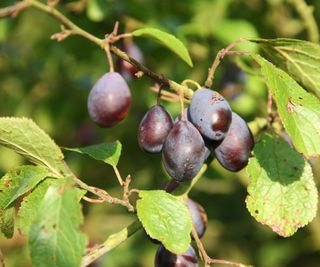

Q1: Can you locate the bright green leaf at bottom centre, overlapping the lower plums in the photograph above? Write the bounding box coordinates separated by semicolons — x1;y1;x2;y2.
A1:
137;190;192;254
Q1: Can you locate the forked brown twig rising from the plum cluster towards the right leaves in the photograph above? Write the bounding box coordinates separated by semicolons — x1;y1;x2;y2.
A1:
205;38;247;88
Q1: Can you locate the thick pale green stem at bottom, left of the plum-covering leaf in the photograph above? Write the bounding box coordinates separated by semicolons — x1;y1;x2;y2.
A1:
81;220;141;267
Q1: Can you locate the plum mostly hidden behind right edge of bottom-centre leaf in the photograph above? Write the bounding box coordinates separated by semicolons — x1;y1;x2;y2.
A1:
186;198;208;238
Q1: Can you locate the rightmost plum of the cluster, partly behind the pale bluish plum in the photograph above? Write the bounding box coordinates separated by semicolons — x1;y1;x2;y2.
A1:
214;112;254;172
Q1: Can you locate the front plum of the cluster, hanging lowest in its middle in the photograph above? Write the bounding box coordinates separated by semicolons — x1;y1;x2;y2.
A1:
162;120;205;181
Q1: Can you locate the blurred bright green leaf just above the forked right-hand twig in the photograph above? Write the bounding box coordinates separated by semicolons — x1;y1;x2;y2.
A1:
212;19;259;53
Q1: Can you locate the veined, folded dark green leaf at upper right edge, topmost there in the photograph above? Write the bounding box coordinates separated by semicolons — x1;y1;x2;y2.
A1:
251;38;320;98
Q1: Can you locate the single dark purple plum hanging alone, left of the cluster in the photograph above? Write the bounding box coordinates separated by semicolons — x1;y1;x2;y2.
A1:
88;72;131;127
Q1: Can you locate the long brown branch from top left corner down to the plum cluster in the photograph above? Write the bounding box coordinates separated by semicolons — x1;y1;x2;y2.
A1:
9;0;193;99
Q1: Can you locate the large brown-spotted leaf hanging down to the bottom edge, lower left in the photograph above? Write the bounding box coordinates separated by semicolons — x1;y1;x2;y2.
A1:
29;179;86;267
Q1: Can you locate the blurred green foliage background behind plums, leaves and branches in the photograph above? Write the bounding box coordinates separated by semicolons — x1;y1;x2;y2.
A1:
0;0;320;267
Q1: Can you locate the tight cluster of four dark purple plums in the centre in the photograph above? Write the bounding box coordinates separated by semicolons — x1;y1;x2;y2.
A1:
138;88;254;182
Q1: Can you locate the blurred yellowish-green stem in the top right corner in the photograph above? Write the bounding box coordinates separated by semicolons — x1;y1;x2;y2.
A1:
289;0;319;43
